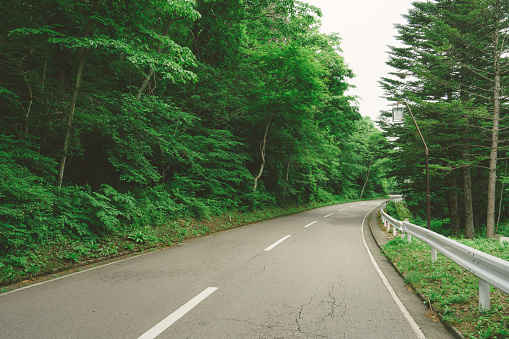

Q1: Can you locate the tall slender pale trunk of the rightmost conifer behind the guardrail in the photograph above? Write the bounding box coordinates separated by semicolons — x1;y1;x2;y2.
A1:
486;30;500;238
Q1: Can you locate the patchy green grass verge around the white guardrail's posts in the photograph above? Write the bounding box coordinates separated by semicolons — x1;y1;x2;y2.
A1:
383;237;509;338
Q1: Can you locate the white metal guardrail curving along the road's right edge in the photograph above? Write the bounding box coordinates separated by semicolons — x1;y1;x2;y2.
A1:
380;203;509;310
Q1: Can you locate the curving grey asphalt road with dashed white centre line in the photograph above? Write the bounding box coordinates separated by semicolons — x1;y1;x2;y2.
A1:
0;201;452;339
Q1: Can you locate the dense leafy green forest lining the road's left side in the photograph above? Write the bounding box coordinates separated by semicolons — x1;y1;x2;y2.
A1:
0;0;391;283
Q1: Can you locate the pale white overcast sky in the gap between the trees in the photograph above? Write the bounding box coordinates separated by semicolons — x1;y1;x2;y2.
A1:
302;0;414;120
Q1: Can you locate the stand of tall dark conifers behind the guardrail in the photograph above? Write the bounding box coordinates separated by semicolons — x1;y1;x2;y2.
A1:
379;0;509;238
